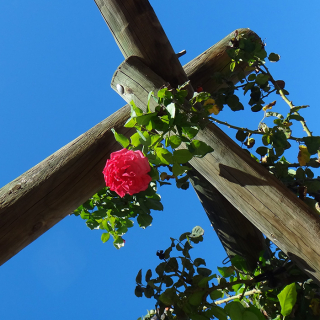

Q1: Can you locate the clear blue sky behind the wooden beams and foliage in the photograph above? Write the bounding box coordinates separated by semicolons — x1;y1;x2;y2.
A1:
0;0;320;320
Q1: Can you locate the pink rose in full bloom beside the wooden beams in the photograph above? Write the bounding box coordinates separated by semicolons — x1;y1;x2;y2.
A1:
102;149;151;198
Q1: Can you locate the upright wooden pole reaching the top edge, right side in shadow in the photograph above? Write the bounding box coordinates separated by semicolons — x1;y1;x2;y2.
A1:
95;0;188;87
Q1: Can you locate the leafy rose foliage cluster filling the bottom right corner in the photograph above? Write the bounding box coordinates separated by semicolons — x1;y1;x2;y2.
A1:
135;227;320;320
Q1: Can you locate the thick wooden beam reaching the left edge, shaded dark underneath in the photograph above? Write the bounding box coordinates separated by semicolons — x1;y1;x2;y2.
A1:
0;106;133;264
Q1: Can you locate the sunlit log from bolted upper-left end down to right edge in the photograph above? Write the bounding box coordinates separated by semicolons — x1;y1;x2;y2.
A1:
112;57;320;283
